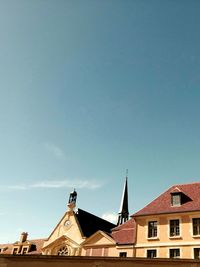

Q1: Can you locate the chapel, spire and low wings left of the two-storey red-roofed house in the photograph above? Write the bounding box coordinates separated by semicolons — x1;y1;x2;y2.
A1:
0;177;135;257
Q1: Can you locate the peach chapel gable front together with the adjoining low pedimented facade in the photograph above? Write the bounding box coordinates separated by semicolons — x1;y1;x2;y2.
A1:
42;209;134;257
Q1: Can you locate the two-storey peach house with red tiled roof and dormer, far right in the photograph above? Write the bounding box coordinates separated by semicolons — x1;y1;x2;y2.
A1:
132;183;200;259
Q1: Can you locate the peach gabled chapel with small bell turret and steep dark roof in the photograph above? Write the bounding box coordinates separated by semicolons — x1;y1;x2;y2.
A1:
42;190;116;256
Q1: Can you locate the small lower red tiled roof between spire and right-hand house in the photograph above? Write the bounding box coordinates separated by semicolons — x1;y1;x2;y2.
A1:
111;219;136;245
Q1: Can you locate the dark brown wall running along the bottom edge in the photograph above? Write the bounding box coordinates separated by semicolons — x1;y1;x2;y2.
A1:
0;255;200;267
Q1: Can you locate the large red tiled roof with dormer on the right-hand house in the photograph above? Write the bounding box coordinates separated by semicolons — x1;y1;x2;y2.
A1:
132;183;200;217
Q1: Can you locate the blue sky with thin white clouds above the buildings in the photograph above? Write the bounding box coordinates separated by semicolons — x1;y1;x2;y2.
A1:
0;0;200;243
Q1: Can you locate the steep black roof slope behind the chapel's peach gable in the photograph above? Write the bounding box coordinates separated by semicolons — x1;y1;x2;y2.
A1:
75;209;116;237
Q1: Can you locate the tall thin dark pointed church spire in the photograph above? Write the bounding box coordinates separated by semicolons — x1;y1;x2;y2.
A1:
117;170;129;225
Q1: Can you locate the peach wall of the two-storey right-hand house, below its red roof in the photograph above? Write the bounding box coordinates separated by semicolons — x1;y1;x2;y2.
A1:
136;212;200;258
